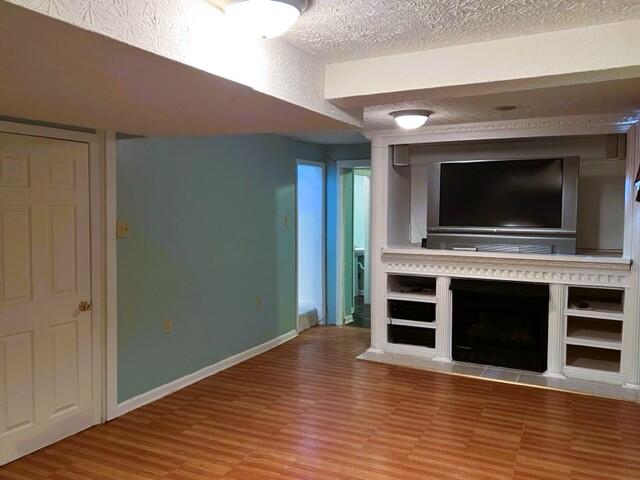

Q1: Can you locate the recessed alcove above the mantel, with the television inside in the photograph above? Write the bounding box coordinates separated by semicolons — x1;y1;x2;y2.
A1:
387;134;626;256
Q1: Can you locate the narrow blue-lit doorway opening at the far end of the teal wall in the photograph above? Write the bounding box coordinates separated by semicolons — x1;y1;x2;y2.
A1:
296;160;326;332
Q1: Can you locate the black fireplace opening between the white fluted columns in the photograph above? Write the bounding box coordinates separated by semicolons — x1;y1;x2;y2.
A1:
451;279;549;372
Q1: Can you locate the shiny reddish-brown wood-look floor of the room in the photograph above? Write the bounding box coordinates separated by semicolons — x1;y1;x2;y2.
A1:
0;327;640;480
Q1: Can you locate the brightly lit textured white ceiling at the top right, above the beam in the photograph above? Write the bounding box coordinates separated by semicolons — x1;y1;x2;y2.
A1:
285;0;640;61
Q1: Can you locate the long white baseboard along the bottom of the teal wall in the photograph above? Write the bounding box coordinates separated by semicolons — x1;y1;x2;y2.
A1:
114;330;298;420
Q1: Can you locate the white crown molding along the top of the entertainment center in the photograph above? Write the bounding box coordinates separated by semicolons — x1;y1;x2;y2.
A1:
364;114;640;146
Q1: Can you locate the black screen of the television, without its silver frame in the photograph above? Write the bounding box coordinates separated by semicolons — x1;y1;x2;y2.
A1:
440;159;563;228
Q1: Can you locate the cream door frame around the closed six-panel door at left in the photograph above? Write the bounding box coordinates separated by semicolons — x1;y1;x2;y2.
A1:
0;121;117;425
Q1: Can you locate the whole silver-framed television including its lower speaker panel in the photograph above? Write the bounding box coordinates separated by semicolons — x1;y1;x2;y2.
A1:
427;157;579;253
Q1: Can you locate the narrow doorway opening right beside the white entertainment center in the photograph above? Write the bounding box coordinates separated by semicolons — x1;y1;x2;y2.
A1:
338;161;371;328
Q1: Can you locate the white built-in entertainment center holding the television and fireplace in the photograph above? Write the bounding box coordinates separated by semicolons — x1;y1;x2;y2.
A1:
370;116;640;387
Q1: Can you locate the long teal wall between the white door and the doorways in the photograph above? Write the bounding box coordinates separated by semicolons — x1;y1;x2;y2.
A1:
117;135;298;401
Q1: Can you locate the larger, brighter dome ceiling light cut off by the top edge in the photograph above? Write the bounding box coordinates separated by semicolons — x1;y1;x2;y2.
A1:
224;0;307;39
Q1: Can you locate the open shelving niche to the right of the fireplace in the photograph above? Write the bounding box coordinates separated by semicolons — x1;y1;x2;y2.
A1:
564;286;624;380
